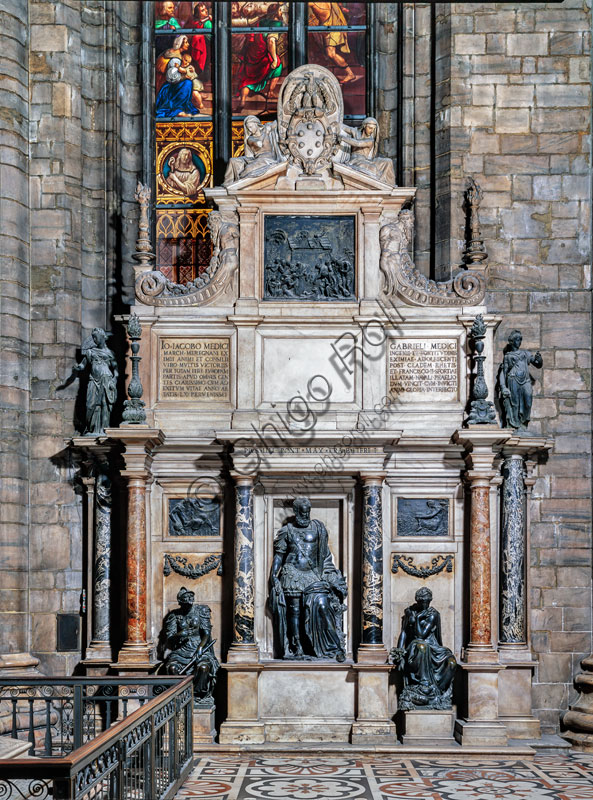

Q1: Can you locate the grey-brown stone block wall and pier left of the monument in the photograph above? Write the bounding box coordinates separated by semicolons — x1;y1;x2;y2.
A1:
0;0;142;673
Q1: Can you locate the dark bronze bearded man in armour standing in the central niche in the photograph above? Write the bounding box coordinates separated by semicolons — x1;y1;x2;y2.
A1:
269;497;348;661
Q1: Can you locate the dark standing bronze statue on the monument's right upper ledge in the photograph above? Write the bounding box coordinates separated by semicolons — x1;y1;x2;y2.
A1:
498;330;544;431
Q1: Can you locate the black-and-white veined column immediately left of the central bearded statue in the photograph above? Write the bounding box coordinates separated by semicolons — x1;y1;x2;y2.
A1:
228;475;259;661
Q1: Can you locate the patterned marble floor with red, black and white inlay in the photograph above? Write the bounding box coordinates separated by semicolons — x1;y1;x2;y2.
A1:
176;753;593;800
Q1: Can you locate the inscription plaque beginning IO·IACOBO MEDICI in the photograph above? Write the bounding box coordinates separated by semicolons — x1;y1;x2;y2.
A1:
159;336;231;403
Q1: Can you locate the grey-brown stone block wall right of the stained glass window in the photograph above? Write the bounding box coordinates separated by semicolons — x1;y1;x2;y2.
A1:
450;0;591;731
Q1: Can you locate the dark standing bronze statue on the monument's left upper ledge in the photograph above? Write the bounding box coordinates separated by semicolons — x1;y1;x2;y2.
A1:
71;328;118;434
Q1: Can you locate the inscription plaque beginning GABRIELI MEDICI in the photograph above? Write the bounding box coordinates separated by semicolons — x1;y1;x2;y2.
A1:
389;338;458;402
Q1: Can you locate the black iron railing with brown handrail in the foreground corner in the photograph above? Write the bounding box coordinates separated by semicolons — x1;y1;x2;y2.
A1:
0;677;193;800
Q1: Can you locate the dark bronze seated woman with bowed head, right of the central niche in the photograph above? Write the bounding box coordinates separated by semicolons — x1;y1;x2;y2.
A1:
389;587;457;711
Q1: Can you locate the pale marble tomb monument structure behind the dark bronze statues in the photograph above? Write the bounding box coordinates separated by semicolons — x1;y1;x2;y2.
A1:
120;65;533;745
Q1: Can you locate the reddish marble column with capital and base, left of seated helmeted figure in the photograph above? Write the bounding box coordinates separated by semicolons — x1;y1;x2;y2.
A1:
105;425;165;674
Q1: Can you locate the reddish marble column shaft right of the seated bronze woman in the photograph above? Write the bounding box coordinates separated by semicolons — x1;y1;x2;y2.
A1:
468;472;492;650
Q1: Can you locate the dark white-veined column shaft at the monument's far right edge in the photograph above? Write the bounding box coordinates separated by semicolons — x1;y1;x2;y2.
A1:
500;454;527;647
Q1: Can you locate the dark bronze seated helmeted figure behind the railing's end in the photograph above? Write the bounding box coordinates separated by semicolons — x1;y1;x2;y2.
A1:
163;587;220;701
